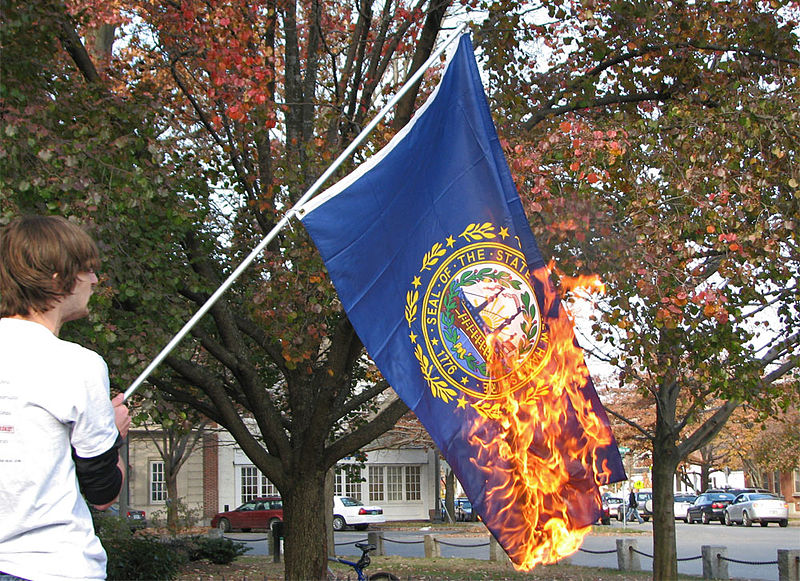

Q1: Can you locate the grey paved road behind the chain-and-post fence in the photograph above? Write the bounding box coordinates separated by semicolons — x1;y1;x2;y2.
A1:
225;522;800;581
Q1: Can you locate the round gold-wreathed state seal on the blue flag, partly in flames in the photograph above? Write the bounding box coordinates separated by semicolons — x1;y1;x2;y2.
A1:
405;223;546;410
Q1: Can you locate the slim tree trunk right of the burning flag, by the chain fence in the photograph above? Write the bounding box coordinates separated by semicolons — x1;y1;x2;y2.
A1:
653;421;680;579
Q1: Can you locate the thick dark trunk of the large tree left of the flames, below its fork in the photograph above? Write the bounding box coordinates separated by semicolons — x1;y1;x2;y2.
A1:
281;470;328;581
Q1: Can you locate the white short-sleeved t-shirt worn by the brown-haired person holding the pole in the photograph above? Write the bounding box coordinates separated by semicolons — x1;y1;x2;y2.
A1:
0;319;119;581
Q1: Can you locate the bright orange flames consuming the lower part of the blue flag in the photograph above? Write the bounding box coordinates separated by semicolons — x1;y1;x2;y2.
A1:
469;268;613;570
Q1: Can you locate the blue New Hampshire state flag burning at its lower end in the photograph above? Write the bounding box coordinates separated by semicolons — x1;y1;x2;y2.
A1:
299;34;625;569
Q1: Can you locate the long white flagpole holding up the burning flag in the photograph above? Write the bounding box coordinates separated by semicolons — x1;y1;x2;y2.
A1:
124;22;469;399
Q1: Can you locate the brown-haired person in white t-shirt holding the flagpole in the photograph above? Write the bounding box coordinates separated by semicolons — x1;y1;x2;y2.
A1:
0;216;131;581
